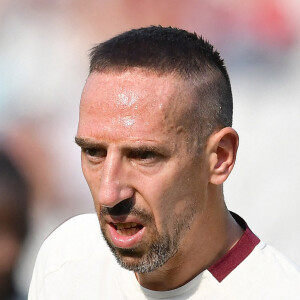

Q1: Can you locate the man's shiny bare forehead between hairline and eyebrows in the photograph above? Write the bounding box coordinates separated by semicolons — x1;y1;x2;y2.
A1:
78;70;193;138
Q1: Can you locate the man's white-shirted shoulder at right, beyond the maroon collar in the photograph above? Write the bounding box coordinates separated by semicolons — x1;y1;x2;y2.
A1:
228;241;300;299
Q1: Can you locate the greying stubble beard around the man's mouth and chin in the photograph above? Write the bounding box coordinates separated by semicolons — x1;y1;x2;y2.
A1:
99;207;195;273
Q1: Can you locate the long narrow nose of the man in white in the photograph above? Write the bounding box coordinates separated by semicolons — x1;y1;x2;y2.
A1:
99;152;134;207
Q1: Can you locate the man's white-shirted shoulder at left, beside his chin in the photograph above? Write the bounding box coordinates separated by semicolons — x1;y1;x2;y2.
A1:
28;214;119;300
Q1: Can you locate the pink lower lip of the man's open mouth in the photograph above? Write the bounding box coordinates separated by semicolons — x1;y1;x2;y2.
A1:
108;224;145;248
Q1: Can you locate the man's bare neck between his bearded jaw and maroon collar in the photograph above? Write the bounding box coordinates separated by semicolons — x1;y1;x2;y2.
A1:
136;186;243;291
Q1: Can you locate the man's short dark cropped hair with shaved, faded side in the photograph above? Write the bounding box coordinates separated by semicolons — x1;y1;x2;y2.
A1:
90;26;233;144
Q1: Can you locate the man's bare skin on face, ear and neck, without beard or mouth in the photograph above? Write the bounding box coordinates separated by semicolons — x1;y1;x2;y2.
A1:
76;69;243;290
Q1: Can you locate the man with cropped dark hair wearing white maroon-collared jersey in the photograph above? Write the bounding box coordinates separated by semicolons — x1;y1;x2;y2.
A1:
29;27;300;299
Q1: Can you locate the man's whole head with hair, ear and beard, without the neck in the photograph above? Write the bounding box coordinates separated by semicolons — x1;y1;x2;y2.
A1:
76;27;237;273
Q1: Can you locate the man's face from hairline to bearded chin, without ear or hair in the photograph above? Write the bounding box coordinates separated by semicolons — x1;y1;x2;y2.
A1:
76;69;208;273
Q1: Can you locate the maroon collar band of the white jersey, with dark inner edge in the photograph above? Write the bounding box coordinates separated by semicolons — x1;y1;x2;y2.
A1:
208;212;260;282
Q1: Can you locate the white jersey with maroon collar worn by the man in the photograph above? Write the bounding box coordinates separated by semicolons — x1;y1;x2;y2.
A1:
29;214;300;300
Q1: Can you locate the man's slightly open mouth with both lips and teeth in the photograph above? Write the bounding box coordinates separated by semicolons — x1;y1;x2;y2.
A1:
107;222;146;249
